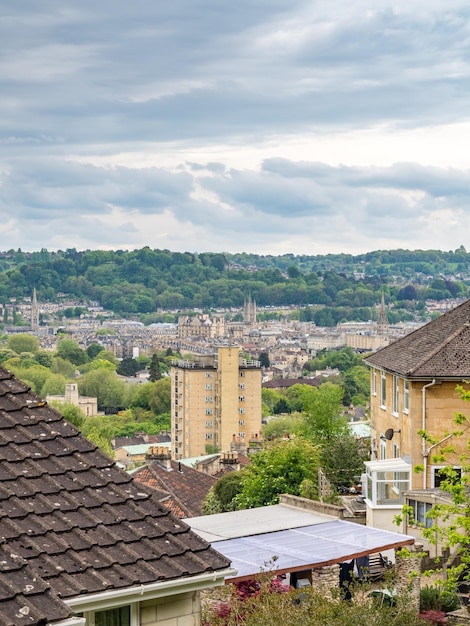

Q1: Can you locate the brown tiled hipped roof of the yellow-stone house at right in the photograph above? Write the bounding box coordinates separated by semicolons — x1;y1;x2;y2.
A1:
366;300;470;380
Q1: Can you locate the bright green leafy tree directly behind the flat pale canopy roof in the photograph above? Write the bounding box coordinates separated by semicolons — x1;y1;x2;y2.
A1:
236;438;320;509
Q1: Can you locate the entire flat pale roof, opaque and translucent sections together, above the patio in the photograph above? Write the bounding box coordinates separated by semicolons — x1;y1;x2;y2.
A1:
185;504;415;582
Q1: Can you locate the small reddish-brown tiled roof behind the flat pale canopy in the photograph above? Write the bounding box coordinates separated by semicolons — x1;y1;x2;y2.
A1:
133;461;216;517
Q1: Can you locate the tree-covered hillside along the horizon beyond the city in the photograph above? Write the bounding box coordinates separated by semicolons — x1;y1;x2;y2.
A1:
0;246;470;325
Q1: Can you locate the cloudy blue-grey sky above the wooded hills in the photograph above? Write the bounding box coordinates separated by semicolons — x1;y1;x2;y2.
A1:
0;0;470;254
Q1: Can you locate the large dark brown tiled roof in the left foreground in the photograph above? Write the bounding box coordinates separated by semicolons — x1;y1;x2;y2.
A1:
0;367;229;626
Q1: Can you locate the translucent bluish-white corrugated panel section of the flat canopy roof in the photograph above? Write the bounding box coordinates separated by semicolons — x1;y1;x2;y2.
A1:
211;520;414;579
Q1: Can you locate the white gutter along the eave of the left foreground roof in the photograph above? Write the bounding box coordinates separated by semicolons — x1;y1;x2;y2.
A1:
63;567;238;612
